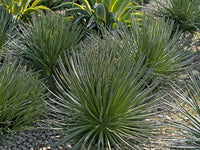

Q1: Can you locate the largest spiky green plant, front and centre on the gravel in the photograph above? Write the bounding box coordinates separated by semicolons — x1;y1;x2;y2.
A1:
49;35;160;150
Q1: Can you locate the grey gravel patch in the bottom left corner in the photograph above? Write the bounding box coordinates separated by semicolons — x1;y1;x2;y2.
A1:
0;130;71;150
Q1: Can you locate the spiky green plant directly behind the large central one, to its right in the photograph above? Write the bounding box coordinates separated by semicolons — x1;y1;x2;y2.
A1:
119;15;190;77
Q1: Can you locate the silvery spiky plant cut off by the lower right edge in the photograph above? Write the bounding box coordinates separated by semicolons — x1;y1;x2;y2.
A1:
168;73;200;149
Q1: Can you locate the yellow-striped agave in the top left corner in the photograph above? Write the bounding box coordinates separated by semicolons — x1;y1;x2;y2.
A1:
0;0;50;19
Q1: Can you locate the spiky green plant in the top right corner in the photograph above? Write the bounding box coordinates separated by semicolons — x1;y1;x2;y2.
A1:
154;0;200;33
